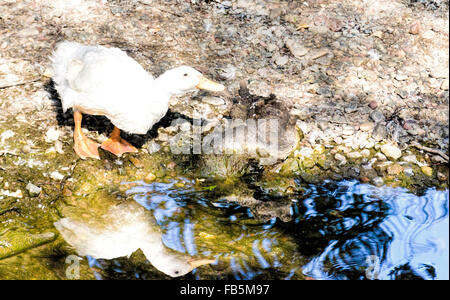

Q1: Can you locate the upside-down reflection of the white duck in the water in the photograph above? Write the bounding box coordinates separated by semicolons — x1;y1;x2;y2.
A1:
54;202;214;277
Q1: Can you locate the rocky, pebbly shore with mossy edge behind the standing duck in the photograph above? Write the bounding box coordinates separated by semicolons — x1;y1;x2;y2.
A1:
0;0;449;278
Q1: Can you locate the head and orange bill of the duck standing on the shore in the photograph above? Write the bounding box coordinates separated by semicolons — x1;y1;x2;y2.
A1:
157;66;225;94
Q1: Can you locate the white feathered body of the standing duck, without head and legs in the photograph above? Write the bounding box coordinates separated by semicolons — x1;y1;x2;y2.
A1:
51;42;170;134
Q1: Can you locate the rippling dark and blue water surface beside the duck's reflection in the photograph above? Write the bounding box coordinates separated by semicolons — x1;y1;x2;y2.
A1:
59;179;449;279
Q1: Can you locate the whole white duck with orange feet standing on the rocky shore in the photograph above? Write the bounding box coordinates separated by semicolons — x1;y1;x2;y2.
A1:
51;42;225;159
